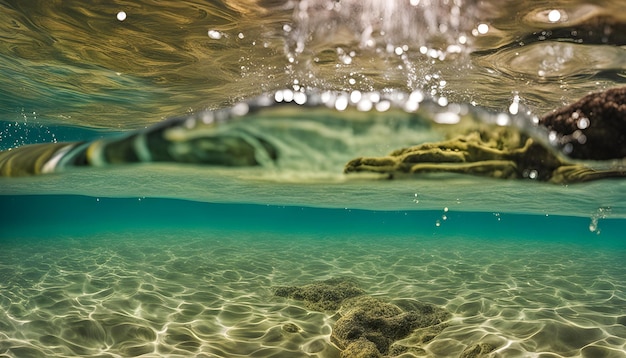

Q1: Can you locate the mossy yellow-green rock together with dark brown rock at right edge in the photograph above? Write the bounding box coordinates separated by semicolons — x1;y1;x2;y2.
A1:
344;88;626;184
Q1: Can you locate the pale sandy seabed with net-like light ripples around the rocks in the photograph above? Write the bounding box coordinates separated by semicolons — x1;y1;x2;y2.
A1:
0;231;626;357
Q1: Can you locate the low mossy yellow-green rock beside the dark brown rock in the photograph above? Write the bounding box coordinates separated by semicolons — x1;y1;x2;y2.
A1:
344;127;626;183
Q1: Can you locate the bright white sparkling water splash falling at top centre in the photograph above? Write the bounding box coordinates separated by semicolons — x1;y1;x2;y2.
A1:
282;0;478;93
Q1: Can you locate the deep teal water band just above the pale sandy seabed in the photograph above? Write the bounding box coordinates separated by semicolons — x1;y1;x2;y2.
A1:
1;195;626;242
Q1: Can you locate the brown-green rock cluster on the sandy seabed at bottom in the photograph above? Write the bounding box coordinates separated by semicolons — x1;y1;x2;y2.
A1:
273;278;450;358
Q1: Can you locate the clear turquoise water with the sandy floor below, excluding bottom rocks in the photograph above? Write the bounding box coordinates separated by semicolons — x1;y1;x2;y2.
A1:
0;195;626;357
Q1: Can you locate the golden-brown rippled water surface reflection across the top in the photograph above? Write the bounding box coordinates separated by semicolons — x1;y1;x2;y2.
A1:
0;0;626;129
